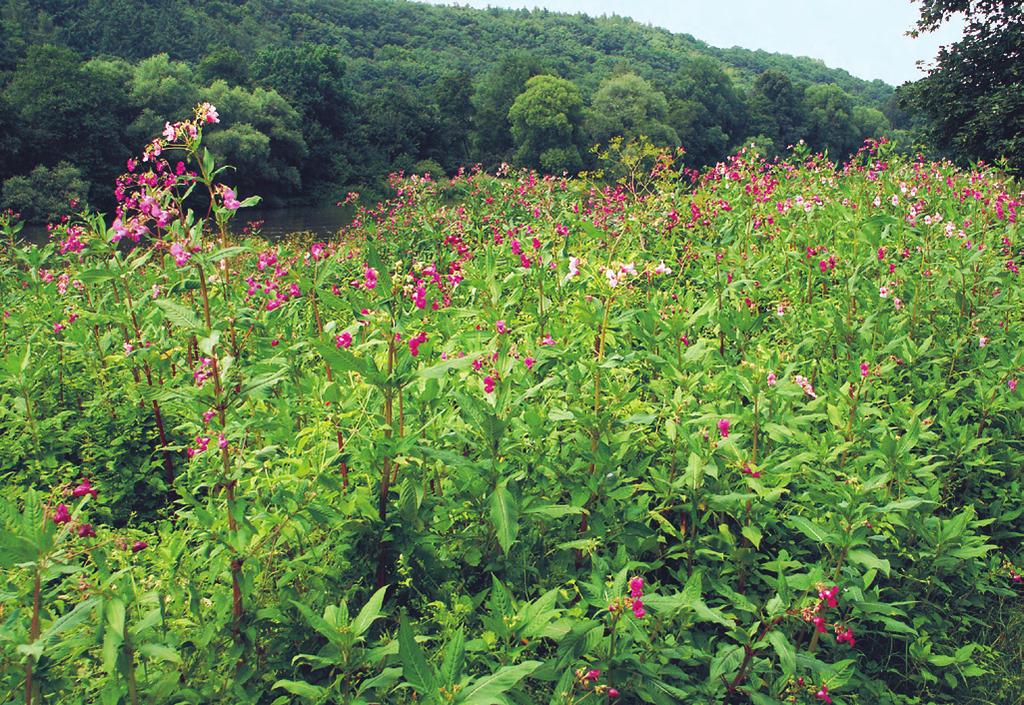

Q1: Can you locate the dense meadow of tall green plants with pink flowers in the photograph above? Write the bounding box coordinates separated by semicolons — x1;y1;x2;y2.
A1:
0;105;1024;705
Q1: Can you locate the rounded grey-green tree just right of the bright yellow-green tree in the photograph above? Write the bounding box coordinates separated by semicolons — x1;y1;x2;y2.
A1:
586;74;679;147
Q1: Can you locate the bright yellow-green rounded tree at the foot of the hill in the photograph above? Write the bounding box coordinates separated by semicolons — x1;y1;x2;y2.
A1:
509;75;583;173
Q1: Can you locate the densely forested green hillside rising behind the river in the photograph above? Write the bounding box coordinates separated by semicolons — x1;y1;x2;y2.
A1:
0;0;906;219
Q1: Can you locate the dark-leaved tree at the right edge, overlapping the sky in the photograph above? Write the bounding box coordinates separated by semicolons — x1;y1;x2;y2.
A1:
900;0;1024;169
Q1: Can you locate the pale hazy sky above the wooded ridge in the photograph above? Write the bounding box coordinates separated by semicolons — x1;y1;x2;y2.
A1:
411;0;962;85
